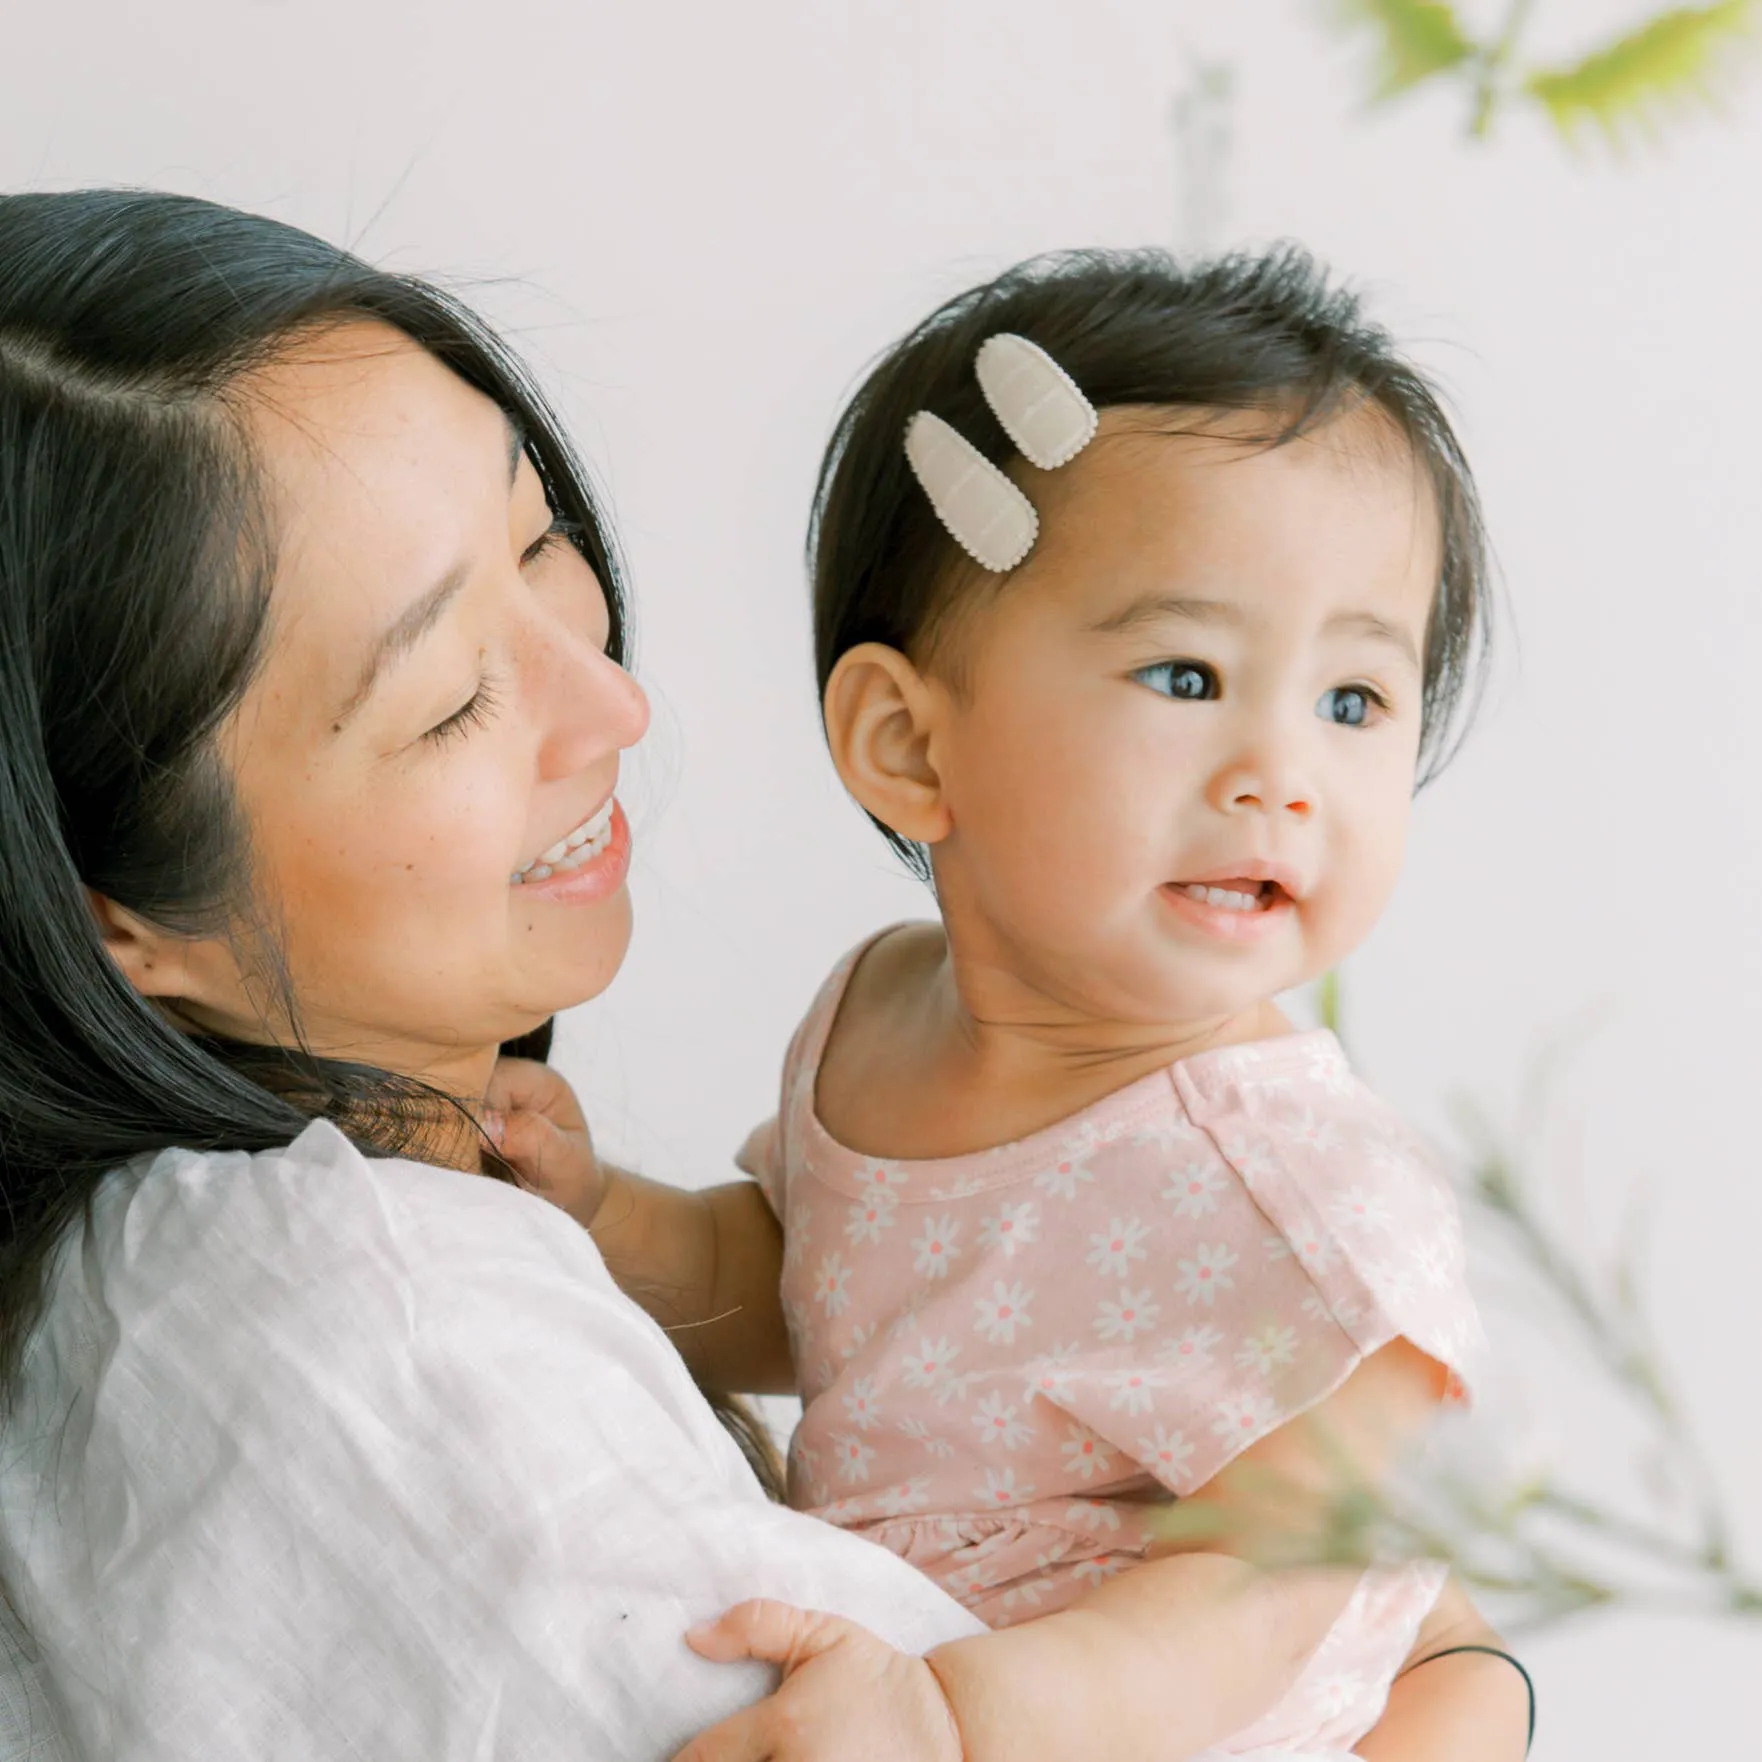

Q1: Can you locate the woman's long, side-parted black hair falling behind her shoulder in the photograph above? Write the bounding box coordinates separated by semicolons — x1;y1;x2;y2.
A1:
0;190;775;1487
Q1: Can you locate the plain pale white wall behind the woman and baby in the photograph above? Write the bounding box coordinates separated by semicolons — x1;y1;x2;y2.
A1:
0;0;1762;1762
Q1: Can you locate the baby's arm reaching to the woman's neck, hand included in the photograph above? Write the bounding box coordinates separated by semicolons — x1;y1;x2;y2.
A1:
486;1059;795;1394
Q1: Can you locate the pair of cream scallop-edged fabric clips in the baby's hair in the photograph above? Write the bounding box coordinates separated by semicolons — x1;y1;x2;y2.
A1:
906;333;1099;574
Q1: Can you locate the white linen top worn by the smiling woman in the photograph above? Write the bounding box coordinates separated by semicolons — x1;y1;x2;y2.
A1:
0;1124;978;1762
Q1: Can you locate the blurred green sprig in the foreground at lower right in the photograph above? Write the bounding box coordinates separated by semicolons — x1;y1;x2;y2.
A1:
1158;1000;1762;1630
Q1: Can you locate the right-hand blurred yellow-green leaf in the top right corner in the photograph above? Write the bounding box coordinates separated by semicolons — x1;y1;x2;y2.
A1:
1524;0;1757;146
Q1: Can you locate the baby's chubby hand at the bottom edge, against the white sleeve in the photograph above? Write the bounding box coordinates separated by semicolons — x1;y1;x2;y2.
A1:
673;1600;962;1762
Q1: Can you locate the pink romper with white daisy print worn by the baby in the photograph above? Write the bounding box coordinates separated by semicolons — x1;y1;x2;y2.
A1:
740;944;1482;1755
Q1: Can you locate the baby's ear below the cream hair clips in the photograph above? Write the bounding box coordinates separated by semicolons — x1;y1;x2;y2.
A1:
821;643;950;844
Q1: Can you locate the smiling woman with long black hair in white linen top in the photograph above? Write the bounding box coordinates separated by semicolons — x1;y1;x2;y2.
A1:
0;192;1325;1762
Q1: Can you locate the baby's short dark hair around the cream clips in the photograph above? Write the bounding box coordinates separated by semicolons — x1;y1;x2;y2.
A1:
809;245;1492;872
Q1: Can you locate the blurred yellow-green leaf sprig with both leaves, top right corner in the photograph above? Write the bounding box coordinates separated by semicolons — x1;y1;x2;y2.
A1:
1329;0;1762;150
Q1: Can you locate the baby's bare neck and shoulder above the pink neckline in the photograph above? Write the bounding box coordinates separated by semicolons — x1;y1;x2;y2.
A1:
816;923;1290;1161
